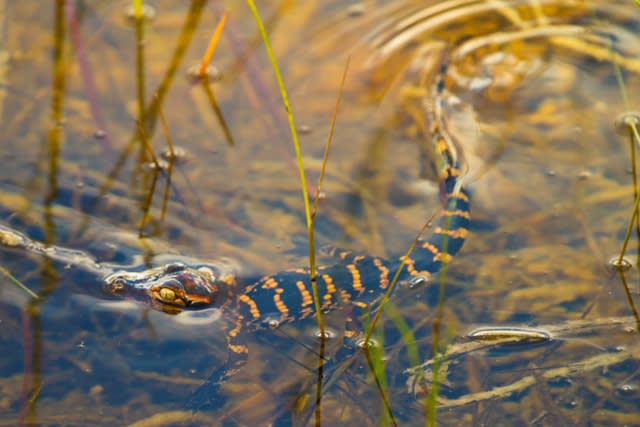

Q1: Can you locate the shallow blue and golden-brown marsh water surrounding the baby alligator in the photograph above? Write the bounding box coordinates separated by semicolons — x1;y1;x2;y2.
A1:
0;0;640;425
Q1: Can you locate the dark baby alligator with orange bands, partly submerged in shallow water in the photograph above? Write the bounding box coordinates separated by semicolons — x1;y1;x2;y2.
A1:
103;72;469;410
